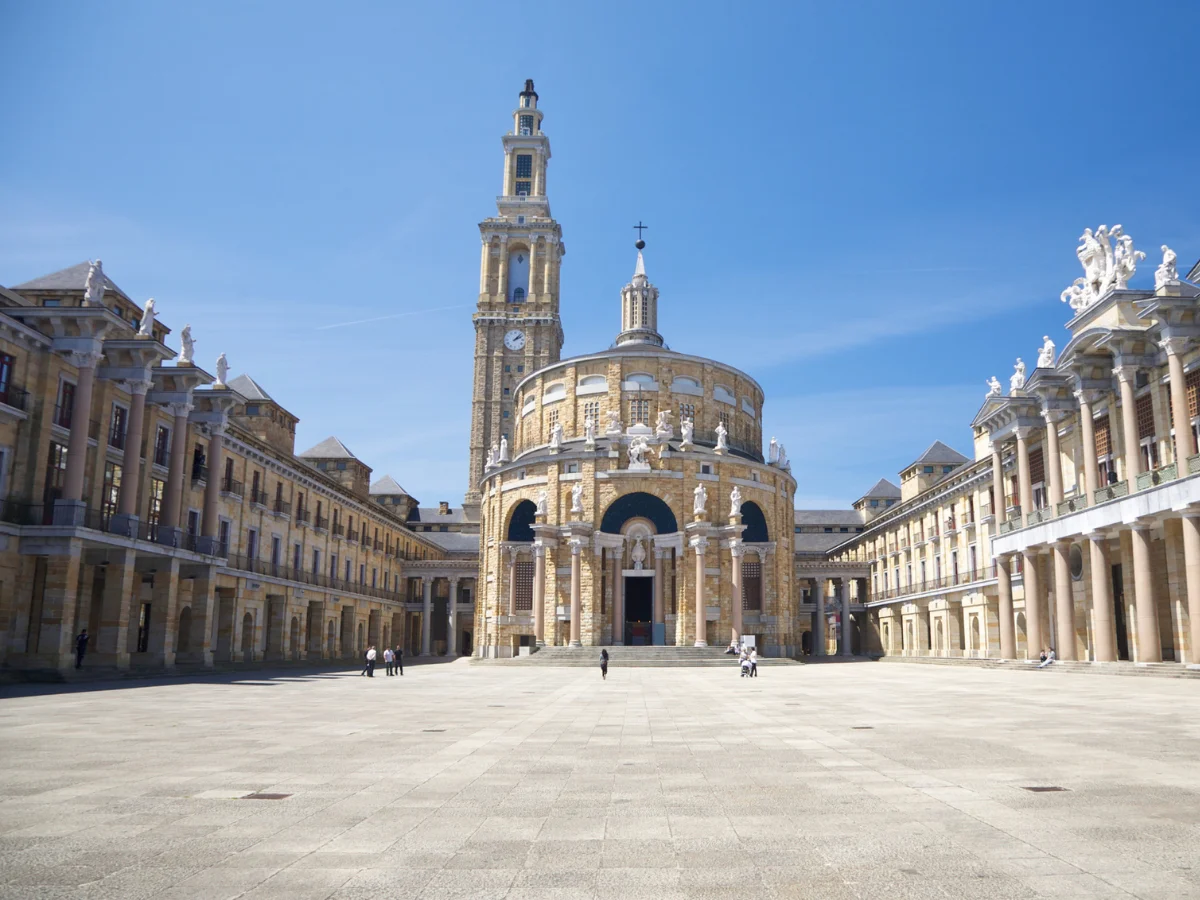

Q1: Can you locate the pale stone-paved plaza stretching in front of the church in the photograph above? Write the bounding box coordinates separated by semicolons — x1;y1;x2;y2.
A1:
0;660;1200;900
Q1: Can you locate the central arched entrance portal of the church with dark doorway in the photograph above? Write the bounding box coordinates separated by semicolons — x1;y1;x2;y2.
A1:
600;491;679;646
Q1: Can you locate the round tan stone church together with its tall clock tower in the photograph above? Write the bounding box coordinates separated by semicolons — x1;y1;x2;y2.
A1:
467;82;799;656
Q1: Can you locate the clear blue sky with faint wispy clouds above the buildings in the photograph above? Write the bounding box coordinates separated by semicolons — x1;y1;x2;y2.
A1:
0;0;1200;506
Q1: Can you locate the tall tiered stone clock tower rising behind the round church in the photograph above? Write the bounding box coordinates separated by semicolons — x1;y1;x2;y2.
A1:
464;79;566;518
